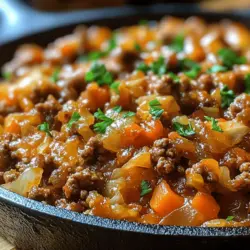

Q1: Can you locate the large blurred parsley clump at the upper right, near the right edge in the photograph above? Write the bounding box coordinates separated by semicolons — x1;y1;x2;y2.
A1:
217;48;247;68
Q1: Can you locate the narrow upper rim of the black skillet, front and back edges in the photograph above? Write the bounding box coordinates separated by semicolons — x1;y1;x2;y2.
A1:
0;4;250;239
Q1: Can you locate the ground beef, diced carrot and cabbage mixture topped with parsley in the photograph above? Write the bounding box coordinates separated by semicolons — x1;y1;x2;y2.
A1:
0;17;250;226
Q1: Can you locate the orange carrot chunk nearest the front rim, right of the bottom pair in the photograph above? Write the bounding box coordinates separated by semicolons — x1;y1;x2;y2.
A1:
192;192;220;220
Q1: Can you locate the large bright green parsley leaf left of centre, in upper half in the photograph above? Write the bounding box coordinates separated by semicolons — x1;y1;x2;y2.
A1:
85;62;113;86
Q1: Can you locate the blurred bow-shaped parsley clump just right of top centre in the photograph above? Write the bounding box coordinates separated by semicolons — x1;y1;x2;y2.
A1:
137;56;167;76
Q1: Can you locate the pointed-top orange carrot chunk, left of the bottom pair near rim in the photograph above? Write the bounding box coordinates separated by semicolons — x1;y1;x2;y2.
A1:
150;180;184;216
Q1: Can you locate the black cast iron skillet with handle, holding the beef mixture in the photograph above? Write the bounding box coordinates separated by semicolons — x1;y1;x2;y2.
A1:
0;0;250;250
